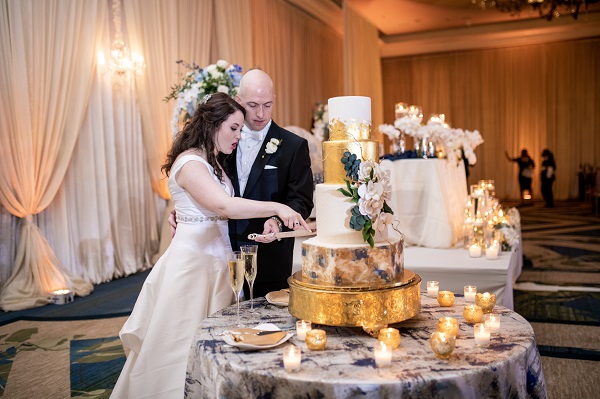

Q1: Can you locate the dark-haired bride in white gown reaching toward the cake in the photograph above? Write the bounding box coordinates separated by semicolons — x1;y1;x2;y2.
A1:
111;93;310;399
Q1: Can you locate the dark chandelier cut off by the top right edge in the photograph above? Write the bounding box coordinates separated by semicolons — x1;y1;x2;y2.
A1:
471;0;599;21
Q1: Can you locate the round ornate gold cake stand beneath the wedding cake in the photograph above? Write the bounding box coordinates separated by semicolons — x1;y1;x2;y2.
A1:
288;269;421;333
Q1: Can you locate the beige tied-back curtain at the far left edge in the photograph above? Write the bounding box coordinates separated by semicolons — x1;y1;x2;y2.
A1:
0;0;106;310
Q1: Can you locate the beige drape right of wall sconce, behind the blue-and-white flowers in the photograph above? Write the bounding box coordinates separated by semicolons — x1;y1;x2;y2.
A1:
124;0;216;198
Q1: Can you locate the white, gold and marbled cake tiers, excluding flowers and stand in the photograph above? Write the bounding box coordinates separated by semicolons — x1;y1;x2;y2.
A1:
302;96;404;286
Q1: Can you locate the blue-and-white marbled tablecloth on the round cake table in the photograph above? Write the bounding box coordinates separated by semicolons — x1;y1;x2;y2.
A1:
186;292;547;399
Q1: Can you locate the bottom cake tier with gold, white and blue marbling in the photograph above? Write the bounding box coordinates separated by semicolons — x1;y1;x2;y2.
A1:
302;236;404;286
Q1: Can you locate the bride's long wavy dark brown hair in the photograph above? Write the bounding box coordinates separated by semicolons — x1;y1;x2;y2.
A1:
161;93;246;180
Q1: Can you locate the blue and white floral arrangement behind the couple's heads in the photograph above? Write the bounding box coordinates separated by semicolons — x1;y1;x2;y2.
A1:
164;60;242;136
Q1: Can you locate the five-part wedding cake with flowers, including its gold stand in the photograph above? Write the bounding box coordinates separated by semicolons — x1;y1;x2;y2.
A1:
288;96;421;328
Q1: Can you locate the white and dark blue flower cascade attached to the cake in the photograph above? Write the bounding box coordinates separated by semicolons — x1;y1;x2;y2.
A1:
338;151;394;248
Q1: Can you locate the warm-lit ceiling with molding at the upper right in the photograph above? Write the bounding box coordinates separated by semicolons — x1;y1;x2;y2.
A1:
287;0;600;58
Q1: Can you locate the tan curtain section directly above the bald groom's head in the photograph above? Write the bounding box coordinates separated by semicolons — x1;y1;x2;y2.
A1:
251;0;343;130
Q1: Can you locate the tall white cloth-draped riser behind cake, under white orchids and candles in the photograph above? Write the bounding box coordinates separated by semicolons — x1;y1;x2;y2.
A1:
381;159;467;248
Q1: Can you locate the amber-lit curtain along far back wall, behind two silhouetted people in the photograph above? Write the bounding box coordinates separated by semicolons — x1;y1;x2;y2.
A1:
382;38;600;199
